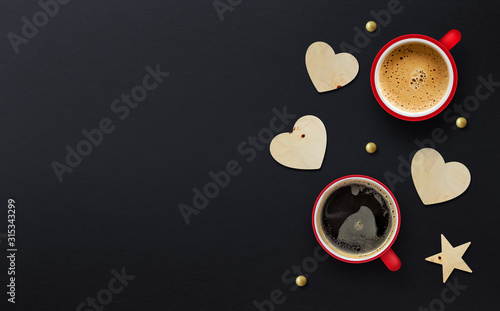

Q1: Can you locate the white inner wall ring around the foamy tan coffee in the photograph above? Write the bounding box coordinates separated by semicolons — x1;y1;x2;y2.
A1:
375;38;455;118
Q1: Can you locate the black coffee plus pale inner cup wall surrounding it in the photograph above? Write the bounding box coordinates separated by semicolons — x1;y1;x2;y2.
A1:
316;180;397;258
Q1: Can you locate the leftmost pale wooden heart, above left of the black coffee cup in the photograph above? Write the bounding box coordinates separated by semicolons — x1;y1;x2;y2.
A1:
269;115;326;170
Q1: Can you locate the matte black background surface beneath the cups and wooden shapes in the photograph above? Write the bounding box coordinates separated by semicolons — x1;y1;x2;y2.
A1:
0;0;500;311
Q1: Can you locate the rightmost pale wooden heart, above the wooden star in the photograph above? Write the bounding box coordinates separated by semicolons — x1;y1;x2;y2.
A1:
411;148;471;205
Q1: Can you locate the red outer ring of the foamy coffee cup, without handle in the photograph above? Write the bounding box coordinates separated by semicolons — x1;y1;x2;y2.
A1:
370;34;458;121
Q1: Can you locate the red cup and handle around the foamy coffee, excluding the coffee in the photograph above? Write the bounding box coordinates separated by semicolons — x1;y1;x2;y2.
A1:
370;29;461;121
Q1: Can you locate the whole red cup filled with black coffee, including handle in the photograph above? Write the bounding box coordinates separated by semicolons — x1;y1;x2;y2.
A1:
312;175;401;271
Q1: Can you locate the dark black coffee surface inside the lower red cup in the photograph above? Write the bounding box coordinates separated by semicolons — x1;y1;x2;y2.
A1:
321;184;392;254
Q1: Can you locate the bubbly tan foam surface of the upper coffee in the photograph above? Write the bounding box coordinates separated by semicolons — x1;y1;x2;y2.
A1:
379;42;450;112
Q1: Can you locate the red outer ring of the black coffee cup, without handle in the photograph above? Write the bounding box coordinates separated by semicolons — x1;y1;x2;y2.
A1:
312;175;401;263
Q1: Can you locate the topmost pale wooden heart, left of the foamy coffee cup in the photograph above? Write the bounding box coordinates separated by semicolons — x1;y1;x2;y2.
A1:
306;41;359;93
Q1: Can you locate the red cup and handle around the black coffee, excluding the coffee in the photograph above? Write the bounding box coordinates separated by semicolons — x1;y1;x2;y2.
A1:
312;175;401;271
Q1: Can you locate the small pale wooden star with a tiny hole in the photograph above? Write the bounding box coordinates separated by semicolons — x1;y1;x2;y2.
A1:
425;234;472;283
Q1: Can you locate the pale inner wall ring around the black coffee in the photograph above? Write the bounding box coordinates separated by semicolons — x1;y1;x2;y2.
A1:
314;177;400;262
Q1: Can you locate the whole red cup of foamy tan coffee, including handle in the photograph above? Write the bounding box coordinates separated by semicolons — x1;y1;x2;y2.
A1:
370;29;461;121
